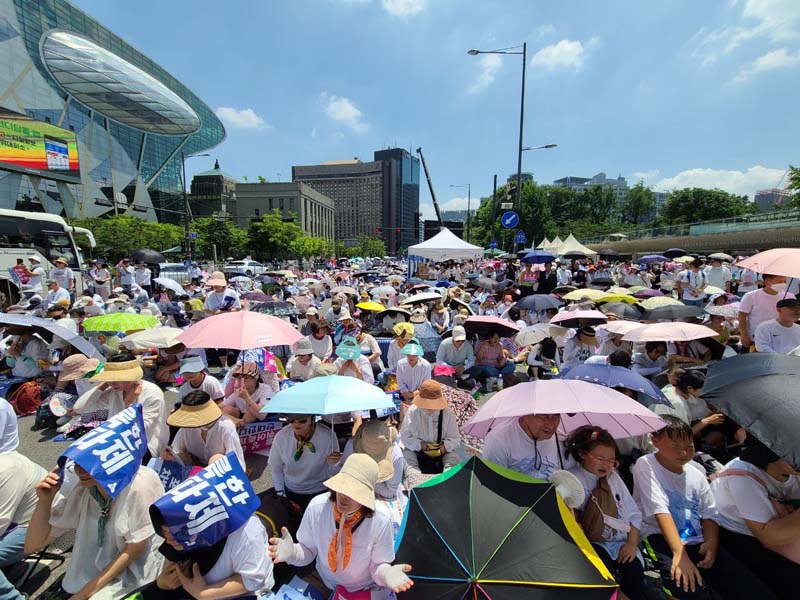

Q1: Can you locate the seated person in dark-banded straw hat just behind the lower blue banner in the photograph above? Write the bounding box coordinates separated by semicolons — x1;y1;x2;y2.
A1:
161;390;245;467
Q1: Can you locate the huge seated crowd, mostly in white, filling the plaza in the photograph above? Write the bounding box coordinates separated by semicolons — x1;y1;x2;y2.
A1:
0;252;800;600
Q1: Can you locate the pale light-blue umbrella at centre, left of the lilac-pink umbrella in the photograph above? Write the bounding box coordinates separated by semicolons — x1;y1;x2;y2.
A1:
261;375;394;415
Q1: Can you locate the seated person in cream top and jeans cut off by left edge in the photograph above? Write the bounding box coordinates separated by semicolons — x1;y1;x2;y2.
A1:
0;450;47;599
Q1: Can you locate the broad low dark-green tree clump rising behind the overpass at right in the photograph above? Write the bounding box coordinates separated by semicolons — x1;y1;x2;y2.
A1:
661;188;758;224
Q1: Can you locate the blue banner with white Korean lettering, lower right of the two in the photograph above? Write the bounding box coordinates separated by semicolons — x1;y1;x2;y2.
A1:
153;452;261;549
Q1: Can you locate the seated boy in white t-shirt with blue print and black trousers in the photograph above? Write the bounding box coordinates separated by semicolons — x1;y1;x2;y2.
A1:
633;415;774;600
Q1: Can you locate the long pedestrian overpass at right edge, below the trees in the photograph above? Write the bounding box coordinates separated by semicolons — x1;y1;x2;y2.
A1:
581;209;800;255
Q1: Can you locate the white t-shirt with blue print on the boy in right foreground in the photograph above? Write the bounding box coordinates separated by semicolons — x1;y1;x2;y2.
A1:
633;454;717;545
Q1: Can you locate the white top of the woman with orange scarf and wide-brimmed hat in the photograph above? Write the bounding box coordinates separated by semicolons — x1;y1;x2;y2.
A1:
297;493;394;592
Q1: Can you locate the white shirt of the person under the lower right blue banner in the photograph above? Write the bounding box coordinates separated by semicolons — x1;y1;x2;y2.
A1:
205;515;275;592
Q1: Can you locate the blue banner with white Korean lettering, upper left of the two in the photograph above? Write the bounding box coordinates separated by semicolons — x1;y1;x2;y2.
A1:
58;404;147;498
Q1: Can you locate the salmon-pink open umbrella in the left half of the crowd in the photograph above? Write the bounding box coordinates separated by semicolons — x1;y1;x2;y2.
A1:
178;310;303;350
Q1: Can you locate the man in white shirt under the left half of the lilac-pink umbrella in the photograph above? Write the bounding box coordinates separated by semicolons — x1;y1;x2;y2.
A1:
483;414;575;481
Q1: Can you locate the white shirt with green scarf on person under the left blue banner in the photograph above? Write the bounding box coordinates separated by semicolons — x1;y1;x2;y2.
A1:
50;467;164;596
